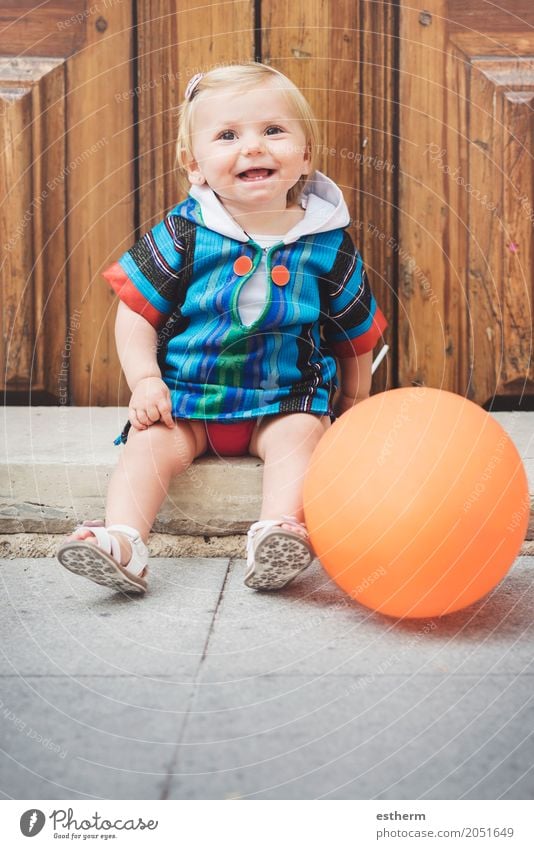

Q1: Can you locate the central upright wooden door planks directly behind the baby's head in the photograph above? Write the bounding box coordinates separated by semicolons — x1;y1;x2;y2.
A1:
137;0;398;398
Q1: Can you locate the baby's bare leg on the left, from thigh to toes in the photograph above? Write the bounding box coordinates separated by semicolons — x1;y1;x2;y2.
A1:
68;420;206;565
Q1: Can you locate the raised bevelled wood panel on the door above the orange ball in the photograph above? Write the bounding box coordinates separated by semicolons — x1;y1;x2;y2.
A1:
469;57;534;401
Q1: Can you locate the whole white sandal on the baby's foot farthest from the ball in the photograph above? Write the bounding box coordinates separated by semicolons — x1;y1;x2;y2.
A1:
56;522;148;593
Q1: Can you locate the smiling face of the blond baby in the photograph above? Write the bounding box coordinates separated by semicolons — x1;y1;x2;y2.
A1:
189;83;309;214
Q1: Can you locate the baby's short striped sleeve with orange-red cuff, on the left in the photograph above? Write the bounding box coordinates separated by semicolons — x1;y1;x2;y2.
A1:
102;214;185;330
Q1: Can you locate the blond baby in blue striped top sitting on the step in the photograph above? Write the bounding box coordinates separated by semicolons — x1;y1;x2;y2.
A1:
57;63;386;593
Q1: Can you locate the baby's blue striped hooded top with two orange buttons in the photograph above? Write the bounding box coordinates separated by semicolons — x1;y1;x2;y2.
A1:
104;172;386;420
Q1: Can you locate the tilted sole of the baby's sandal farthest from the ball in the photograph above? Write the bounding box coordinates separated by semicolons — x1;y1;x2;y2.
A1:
56;540;147;593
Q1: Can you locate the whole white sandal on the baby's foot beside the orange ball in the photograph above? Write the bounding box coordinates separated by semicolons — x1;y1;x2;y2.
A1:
244;516;314;590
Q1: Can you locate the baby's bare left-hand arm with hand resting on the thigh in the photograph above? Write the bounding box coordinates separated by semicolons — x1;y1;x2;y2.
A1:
115;301;174;430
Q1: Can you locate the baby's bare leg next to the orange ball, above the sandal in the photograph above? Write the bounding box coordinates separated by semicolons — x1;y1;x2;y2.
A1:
249;413;330;535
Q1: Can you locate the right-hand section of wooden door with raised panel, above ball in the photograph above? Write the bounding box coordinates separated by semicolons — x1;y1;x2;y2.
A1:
397;0;534;403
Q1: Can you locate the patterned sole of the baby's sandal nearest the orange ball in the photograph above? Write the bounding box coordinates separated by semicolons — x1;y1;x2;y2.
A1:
244;531;313;590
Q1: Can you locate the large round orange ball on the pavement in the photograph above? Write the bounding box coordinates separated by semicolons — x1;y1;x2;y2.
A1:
304;387;529;618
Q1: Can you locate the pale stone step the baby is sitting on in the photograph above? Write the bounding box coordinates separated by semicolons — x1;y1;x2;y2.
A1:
0;407;534;556
